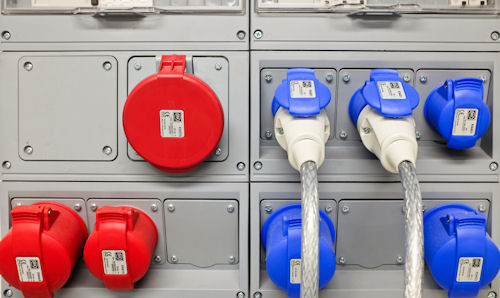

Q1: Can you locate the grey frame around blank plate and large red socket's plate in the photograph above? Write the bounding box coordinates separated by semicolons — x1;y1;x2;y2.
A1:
0;51;249;182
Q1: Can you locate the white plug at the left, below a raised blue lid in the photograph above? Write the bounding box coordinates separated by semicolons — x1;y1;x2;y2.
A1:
274;108;330;171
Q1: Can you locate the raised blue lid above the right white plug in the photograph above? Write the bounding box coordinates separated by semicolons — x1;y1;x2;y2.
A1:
349;69;420;125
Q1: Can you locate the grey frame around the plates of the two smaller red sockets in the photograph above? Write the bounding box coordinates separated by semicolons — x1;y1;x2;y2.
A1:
0;181;249;298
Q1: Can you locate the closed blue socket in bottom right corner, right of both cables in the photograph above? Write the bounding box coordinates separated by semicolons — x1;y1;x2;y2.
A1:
424;204;500;298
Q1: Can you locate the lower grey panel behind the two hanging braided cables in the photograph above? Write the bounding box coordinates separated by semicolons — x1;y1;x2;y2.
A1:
250;183;500;298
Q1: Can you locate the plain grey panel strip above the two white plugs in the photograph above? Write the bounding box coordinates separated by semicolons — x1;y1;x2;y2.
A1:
250;14;500;51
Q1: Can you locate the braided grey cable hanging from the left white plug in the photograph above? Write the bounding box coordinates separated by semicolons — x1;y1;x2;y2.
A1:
300;161;319;298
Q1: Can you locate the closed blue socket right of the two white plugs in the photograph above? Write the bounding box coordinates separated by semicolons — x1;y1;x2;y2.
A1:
424;78;491;149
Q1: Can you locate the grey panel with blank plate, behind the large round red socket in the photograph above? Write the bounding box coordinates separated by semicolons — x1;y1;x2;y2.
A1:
0;51;249;182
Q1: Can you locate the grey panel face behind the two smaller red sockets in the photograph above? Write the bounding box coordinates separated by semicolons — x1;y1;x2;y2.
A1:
0;182;249;298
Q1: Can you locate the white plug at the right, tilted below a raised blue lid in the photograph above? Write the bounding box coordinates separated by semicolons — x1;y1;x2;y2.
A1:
357;106;418;174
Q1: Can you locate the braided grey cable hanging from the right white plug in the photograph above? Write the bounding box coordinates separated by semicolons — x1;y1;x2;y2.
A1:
398;161;424;298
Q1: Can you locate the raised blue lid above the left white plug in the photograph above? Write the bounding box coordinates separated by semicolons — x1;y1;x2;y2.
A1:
272;68;332;117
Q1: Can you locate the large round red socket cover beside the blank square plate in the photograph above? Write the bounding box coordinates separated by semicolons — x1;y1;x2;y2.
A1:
123;55;224;173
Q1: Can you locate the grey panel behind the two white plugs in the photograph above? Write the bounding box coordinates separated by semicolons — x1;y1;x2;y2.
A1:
250;51;500;182
